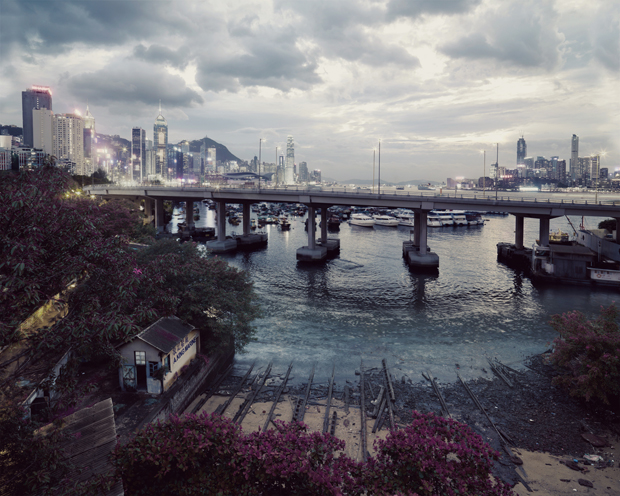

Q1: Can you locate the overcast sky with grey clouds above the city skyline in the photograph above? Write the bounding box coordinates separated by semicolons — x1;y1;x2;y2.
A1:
0;0;620;181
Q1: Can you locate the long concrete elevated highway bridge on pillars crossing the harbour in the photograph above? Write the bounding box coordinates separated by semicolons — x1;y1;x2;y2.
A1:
84;184;620;267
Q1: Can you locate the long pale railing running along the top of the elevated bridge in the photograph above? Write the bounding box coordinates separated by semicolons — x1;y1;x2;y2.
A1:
84;184;620;206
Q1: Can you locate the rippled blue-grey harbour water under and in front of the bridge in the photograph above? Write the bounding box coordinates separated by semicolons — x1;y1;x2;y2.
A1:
170;204;618;382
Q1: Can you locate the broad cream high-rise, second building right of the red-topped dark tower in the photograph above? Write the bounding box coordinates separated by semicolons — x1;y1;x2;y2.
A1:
52;114;86;175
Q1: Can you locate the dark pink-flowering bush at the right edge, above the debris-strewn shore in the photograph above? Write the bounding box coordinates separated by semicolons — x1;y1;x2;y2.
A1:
549;304;620;404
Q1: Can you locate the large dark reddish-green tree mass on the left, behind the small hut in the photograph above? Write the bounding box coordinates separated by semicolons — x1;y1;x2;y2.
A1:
0;167;258;494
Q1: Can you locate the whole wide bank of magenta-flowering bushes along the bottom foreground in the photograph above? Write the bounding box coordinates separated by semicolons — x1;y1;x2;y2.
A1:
114;412;512;496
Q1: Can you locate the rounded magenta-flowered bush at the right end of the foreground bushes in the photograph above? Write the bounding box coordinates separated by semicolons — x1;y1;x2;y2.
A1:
364;411;512;496
